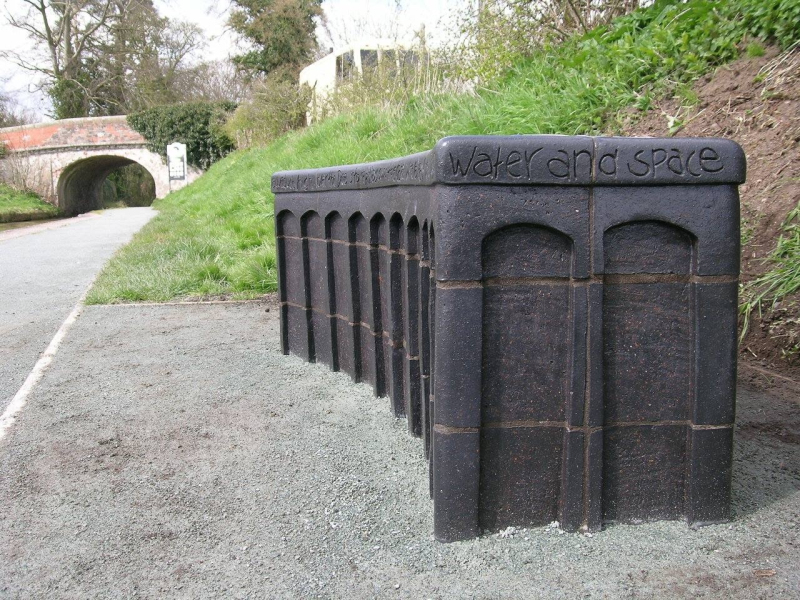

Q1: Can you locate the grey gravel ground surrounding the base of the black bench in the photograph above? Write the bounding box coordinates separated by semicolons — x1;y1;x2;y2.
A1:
0;303;800;600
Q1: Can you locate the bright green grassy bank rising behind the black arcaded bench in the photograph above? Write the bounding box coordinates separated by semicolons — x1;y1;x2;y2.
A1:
88;0;800;303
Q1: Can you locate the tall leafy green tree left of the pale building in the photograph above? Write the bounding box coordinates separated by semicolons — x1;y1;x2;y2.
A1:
228;0;322;79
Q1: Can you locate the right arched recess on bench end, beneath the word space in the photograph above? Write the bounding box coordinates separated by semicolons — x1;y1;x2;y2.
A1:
598;221;695;522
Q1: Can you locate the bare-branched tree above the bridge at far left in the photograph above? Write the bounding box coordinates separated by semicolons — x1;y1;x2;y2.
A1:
2;0;202;118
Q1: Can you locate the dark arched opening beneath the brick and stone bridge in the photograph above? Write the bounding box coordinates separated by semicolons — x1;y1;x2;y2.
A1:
57;155;156;215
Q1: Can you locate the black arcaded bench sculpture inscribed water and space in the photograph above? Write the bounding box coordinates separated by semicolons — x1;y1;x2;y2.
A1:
272;136;745;541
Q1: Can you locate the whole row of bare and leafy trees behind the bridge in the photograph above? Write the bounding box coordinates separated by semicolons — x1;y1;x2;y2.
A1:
0;0;321;119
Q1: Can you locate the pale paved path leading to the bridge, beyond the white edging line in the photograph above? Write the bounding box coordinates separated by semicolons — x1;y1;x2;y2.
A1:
0;208;156;413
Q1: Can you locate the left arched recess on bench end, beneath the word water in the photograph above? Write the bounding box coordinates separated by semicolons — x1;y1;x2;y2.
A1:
479;224;572;530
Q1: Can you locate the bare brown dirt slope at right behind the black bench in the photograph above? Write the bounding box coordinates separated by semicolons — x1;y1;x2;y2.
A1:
625;48;800;379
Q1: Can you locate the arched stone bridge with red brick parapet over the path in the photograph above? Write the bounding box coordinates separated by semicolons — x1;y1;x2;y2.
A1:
0;116;200;215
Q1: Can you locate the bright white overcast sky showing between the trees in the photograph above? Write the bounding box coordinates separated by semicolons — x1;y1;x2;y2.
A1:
0;0;466;119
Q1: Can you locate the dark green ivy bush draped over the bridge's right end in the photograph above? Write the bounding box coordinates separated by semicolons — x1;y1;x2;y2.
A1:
128;102;236;170
